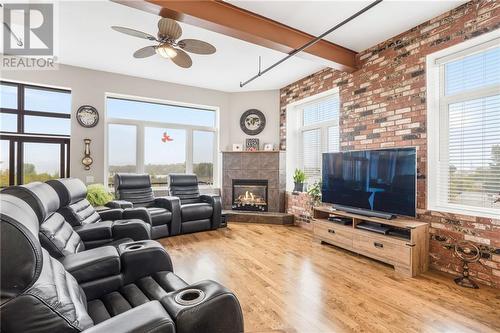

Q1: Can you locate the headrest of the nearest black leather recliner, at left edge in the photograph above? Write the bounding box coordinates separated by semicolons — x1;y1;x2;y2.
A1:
0;192;42;304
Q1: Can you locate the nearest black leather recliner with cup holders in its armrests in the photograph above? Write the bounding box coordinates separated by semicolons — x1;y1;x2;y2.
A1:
0;193;243;333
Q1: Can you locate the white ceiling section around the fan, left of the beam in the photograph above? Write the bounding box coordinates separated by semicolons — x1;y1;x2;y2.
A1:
58;1;324;92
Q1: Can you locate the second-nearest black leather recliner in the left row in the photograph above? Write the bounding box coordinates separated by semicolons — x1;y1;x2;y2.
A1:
1;182;151;258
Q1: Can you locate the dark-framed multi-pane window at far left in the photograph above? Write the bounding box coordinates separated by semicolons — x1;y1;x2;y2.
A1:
0;81;71;187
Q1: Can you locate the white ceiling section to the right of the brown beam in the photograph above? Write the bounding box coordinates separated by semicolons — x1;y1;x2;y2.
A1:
227;0;467;52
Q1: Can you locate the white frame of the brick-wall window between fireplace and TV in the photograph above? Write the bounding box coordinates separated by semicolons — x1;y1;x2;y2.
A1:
286;87;342;191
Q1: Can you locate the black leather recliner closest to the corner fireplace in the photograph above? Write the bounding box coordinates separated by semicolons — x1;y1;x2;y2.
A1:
168;174;222;234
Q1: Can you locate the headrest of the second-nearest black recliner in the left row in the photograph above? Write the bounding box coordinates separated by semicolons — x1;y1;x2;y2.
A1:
2;182;60;223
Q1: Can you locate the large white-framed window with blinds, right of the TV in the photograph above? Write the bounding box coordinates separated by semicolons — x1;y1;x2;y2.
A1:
427;30;500;218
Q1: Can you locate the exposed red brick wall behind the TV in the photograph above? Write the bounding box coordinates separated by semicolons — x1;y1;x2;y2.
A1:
280;1;500;287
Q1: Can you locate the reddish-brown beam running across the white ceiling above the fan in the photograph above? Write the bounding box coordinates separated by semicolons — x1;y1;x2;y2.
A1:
114;0;356;72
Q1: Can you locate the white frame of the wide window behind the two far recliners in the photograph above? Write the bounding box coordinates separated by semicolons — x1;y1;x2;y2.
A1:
105;94;220;189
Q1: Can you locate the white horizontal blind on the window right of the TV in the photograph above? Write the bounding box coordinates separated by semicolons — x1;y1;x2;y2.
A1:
437;48;500;214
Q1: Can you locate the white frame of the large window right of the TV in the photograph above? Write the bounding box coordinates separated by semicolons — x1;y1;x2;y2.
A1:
426;30;500;218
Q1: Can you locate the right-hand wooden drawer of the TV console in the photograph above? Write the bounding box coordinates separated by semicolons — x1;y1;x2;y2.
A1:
353;235;411;267
